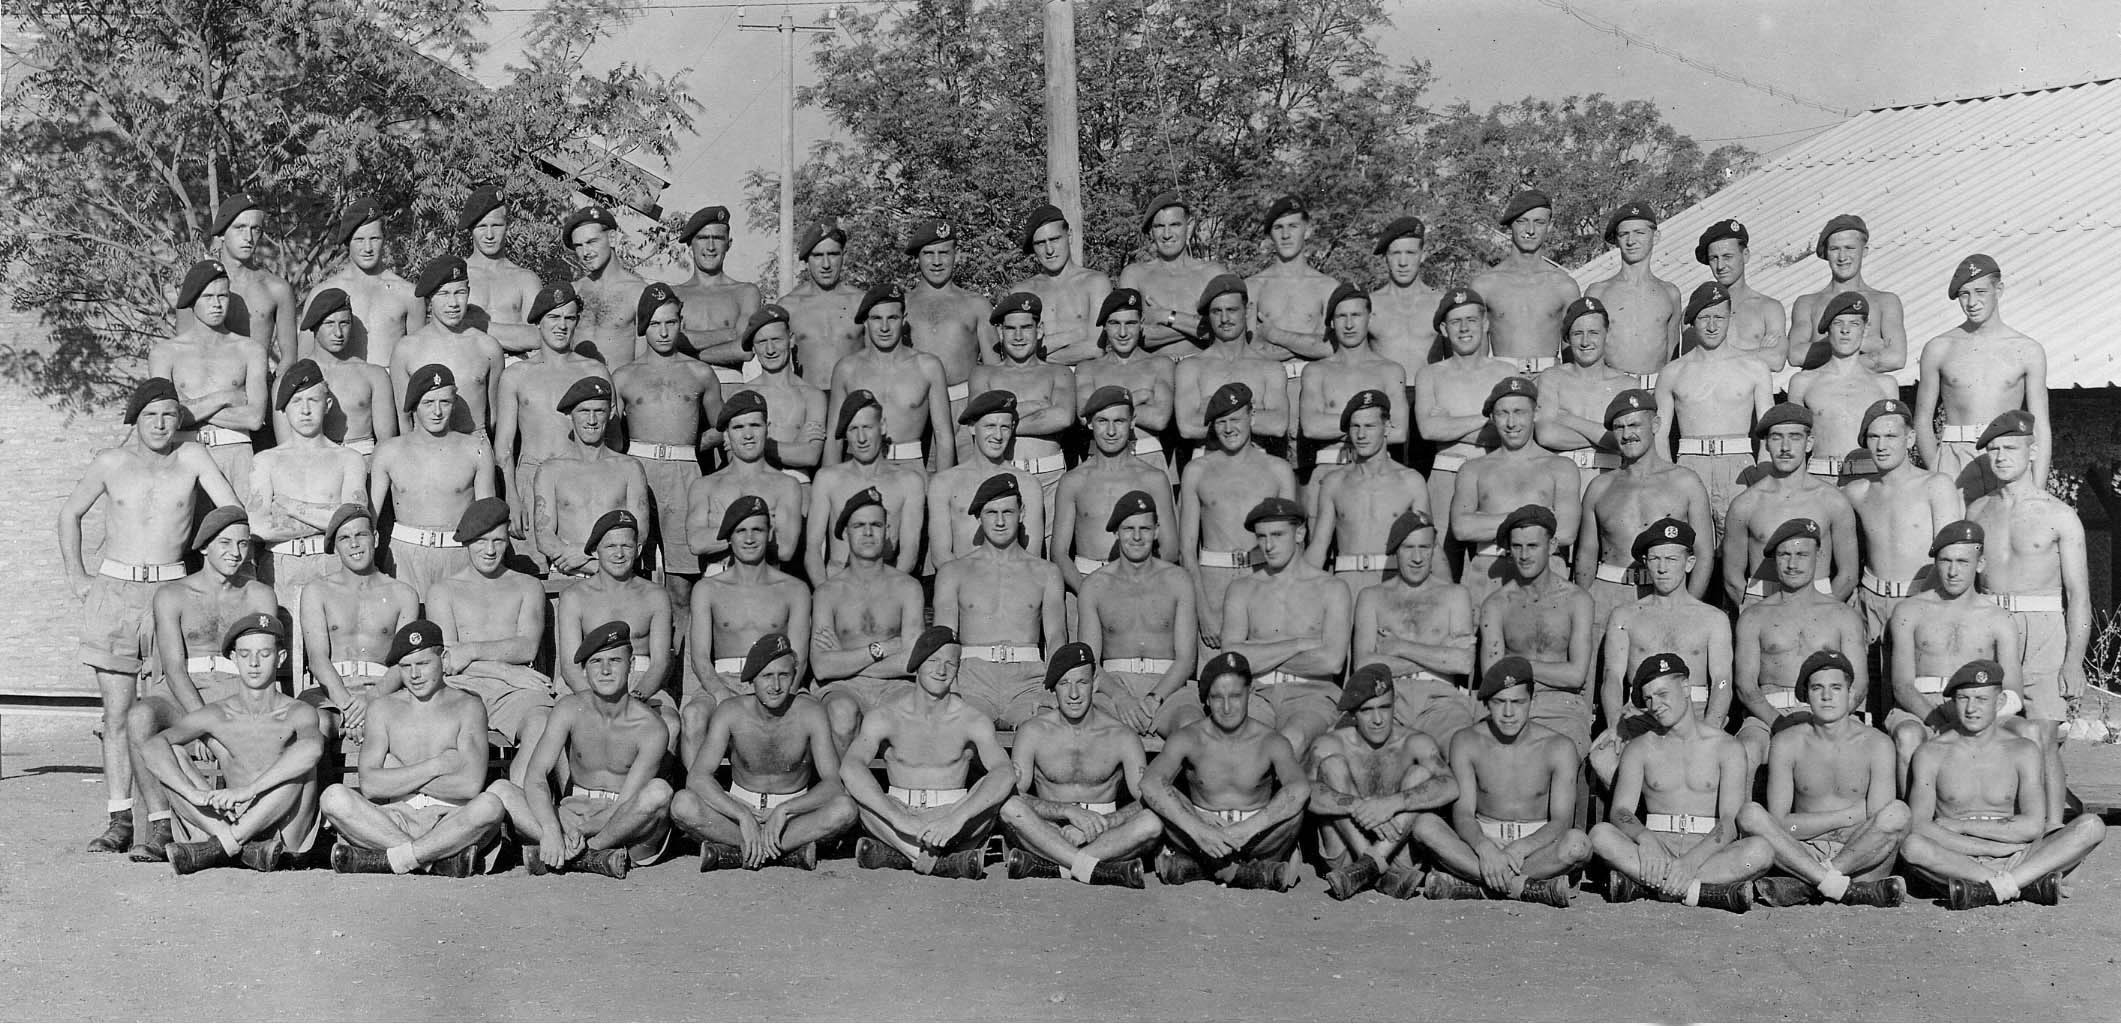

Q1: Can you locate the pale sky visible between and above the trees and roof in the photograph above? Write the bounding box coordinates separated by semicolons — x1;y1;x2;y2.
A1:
492;0;2121;276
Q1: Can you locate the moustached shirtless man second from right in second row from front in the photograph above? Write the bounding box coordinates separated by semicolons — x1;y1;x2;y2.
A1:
1731;517;1871;770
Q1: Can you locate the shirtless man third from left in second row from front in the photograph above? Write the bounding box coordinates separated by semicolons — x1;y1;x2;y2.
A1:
419;498;556;786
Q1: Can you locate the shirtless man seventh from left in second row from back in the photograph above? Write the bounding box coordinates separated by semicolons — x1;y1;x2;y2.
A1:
825;282;957;471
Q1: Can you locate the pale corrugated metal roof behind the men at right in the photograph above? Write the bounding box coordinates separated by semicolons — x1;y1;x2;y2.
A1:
1574;81;2121;388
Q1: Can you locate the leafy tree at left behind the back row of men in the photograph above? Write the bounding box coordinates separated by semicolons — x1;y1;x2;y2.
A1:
0;0;698;407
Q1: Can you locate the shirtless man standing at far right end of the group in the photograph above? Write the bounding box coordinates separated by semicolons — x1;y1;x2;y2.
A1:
1968;409;2091;829
